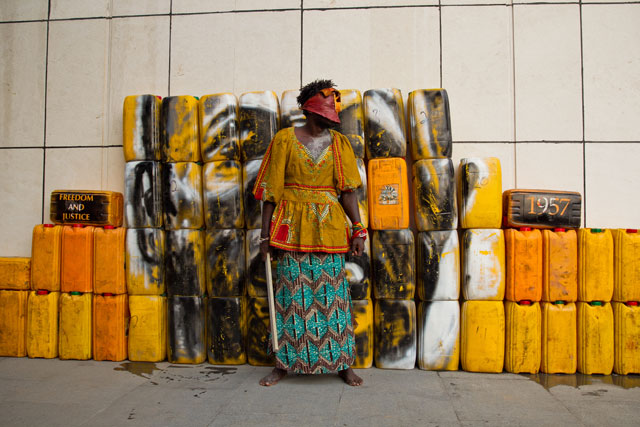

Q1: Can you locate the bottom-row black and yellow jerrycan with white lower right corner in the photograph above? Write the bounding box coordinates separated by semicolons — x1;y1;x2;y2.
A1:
374;299;417;369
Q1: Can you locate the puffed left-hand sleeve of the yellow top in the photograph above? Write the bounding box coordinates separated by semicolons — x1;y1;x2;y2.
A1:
253;131;288;203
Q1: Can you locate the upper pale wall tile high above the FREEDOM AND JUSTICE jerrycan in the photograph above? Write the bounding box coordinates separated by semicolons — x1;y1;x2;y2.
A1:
47;19;109;146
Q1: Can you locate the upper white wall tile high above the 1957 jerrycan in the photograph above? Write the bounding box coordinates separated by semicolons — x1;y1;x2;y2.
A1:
514;5;582;141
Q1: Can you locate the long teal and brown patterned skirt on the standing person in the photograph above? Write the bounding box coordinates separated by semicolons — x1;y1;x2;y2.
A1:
274;251;355;374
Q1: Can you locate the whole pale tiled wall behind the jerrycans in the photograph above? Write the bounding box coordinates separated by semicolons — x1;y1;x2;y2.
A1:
0;0;640;256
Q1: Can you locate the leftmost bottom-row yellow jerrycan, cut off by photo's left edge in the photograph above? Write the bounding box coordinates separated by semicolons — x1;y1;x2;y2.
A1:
0;290;29;357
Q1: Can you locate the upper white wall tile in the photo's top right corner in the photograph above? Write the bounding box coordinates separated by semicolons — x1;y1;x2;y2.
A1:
582;4;640;141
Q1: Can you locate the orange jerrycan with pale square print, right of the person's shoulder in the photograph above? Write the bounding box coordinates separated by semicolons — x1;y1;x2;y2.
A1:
367;158;409;230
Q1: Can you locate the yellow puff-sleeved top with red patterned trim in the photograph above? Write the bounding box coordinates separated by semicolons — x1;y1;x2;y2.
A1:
253;127;362;253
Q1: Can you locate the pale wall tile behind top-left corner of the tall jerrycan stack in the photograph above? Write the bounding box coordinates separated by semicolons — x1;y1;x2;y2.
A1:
105;16;170;145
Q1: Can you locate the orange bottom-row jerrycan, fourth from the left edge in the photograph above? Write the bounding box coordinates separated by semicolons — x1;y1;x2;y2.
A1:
93;293;129;362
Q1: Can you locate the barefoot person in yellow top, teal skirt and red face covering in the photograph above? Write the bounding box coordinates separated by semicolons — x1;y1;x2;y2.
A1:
253;80;367;386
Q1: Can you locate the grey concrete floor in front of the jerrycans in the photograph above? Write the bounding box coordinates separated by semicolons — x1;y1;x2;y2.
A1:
0;358;640;426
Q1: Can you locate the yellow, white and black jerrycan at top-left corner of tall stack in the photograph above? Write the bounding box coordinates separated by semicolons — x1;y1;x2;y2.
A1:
122;95;162;162
